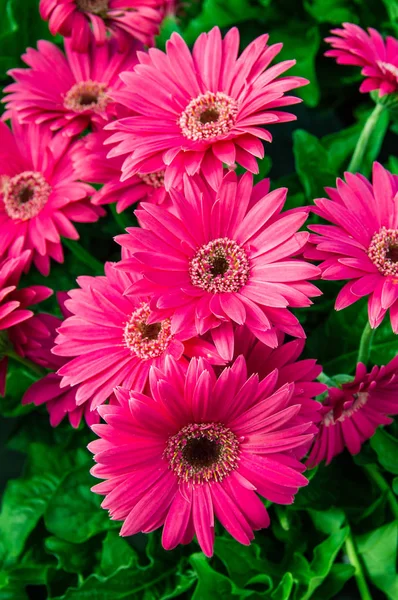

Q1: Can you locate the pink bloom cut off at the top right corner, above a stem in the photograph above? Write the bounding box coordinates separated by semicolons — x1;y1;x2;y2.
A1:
325;23;398;96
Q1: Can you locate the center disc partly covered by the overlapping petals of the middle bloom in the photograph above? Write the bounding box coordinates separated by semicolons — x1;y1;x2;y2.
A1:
123;303;173;360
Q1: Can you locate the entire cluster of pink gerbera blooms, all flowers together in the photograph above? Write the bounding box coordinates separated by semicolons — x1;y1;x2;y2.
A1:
0;0;398;556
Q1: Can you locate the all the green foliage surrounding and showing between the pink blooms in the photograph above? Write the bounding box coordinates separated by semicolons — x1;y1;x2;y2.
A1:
0;0;398;600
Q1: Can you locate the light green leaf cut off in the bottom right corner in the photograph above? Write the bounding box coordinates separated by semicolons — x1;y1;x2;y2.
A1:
355;521;398;600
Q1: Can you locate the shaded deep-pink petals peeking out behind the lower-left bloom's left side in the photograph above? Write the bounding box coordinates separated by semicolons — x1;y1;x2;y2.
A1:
22;294;99;428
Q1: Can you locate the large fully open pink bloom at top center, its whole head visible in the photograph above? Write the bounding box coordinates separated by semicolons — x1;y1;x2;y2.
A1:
108;27;308;189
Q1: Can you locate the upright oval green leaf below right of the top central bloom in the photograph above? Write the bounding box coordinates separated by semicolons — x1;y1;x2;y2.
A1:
293;129;336;200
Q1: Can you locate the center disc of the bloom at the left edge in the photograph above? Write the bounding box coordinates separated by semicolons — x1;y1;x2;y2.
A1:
2;171;51;221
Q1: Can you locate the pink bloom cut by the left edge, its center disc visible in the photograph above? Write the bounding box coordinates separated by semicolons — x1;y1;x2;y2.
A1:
0;115;103;275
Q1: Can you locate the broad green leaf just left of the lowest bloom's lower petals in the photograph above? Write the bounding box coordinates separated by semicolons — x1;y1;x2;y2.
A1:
44;465;116;544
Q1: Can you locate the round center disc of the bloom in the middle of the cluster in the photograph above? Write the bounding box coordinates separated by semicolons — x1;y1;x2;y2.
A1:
189;238;250;294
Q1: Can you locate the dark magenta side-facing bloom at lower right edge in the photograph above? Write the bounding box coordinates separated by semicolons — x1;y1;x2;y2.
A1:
308;356;398;467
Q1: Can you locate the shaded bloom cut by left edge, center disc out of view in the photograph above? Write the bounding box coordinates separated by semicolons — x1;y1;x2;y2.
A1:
0;251;52;396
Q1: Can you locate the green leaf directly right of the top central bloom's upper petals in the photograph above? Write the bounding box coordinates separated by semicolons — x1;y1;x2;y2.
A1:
270;21;321;107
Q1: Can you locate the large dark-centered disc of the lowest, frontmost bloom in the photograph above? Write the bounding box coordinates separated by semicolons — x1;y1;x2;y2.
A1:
163;423;239;484
